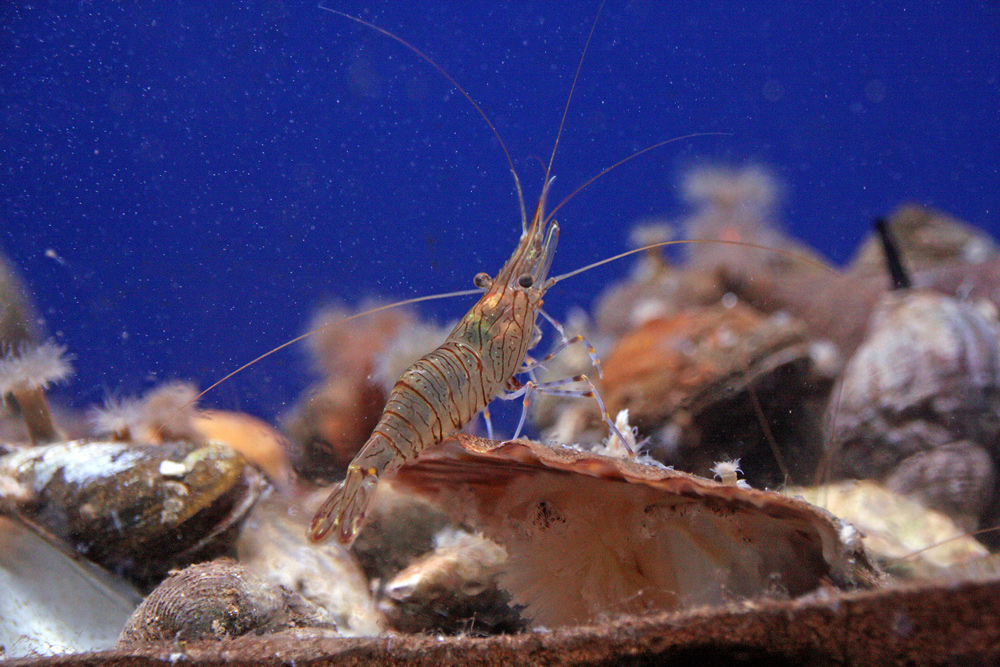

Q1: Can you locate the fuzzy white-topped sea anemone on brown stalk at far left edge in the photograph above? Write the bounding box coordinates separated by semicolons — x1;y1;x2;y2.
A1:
0;341;73;444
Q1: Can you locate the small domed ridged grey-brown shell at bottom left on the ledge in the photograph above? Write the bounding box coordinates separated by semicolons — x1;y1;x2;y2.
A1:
118;559;316;648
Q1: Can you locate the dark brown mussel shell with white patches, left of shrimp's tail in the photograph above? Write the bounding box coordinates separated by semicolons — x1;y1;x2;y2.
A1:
0;442;266;583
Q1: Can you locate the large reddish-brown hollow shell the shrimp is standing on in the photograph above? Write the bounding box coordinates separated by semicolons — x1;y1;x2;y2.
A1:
396;435;874;627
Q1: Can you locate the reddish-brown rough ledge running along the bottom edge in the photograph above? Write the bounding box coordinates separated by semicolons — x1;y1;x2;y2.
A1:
11;578;1000;667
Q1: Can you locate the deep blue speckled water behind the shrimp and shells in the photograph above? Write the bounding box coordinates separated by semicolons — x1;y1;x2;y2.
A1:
0;0;1000;417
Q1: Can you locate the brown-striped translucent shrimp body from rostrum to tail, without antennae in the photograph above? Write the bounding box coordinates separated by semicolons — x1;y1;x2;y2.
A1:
309;181;608;544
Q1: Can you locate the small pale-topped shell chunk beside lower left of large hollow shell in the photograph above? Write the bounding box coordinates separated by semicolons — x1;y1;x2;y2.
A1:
379;529;525;634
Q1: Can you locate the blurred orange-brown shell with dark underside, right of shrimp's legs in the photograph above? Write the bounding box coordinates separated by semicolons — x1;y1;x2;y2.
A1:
600;302;836;486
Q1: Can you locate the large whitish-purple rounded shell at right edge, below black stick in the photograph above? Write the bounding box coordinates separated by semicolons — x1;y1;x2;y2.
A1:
829;290;1000;478
